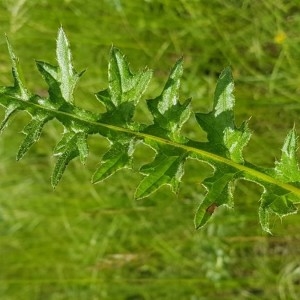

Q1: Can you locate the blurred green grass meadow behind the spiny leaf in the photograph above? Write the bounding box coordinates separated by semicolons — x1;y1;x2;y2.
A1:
0;0;300;300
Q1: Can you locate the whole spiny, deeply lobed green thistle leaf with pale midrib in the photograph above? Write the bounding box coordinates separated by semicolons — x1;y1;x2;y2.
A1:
0;28;300;232
